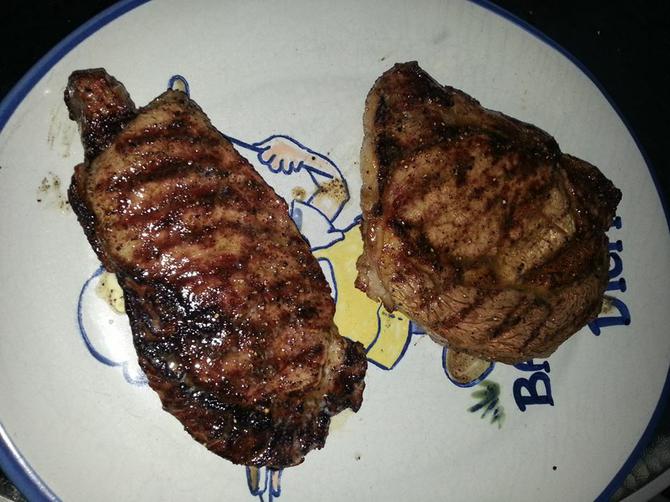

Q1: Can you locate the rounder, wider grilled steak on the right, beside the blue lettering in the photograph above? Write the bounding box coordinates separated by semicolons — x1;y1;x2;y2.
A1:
356;63;621;363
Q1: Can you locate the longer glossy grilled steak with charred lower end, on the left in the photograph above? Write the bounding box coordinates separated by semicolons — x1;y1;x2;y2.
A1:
65;70;366;467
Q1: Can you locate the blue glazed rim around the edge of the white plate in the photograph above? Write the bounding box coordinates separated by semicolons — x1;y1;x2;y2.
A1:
0;0;670;501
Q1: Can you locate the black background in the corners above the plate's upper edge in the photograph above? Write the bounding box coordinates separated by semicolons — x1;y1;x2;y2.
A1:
0;0;670;500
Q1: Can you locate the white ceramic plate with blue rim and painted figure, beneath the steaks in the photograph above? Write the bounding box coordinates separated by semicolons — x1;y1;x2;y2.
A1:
0;0;670;502
